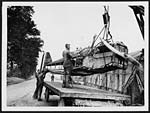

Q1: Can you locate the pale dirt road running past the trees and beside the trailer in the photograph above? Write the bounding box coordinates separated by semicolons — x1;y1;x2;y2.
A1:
7;73;60;106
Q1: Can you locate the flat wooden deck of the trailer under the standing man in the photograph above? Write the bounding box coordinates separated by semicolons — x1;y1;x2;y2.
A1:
44;81;130;100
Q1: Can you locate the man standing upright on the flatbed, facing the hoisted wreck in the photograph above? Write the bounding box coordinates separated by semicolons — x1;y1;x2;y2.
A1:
62;44;73;88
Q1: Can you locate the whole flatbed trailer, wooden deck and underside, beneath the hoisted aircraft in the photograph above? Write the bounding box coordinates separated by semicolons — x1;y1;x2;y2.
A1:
44;81;130;106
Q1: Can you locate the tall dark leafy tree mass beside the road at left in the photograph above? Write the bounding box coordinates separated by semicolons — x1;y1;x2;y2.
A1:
7;6;44;78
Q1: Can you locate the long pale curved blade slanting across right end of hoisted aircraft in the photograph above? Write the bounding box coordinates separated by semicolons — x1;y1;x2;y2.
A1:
101;39;142;67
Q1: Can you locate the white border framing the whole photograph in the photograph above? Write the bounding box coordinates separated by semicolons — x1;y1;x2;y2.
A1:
1;1;149;111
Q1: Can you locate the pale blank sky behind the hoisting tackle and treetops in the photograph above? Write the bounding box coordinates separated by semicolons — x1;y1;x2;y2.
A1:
30;3;145;69
